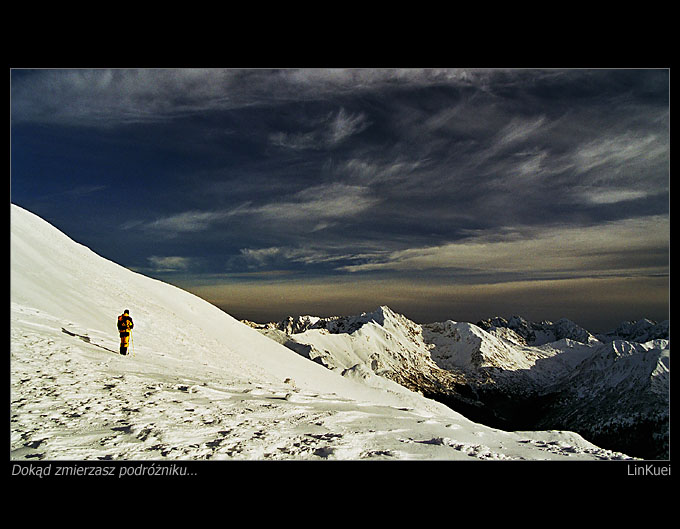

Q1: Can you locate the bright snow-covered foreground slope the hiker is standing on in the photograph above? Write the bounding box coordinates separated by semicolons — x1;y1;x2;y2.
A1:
10;205;628;461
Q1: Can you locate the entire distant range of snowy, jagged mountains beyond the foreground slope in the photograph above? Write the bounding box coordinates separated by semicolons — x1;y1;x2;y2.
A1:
250;307;670;459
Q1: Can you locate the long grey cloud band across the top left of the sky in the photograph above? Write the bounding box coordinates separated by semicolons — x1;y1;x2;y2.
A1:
12;68;484;128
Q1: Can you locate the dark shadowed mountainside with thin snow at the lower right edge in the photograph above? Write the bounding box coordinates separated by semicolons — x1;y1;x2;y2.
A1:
536;339;670;459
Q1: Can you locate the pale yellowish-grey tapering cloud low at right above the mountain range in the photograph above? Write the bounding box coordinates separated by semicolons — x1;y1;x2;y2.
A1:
342;216;670;277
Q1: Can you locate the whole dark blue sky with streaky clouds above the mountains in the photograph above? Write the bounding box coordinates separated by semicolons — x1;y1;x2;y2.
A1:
10;69;670;331
